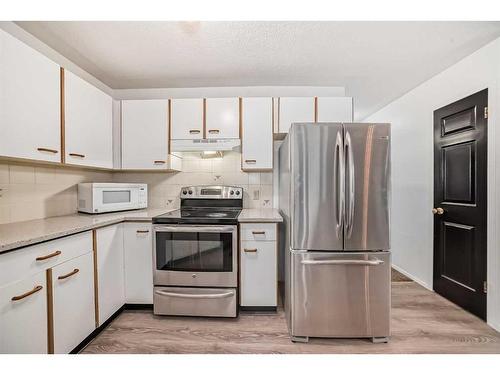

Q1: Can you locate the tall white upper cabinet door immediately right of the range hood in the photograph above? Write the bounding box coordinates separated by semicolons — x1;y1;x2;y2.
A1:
241;98;273;171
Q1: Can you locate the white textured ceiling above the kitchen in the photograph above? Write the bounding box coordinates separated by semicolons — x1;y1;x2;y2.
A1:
17;22;500;119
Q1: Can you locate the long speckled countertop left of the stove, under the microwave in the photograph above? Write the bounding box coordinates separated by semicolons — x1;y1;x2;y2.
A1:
0;208;171;254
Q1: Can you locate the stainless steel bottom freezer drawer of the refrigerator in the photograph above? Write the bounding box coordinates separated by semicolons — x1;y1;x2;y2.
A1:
289;251;391;337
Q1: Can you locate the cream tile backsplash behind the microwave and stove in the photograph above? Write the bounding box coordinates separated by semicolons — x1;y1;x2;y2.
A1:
0;152;273;224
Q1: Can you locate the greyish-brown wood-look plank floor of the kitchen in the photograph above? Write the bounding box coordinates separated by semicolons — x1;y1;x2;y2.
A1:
82;282;500;353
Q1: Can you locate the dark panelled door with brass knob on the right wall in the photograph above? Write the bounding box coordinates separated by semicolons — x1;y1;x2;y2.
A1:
433;89;488;319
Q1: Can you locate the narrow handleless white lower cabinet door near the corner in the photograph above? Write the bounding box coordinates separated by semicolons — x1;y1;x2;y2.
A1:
96;224;125;325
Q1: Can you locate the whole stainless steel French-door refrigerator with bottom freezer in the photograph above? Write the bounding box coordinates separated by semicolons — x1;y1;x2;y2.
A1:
279;123;391;341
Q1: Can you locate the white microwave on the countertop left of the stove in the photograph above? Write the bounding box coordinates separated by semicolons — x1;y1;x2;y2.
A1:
78;182;148;214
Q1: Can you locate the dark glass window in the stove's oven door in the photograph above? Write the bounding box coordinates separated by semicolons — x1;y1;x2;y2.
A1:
156;232;233;272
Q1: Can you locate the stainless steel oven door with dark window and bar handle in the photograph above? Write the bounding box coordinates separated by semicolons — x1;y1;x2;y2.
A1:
153;225;238;287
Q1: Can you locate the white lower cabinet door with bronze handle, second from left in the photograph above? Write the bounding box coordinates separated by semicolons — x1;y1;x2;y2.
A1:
52;252;95;354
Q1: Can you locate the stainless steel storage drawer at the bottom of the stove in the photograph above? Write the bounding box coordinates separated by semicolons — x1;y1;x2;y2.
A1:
153;287;236;318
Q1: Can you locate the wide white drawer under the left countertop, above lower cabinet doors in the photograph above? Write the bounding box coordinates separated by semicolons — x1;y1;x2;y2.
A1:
0;231;92;285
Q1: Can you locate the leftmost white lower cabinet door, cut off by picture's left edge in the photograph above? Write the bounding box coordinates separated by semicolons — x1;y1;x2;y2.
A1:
0;272;47;353
